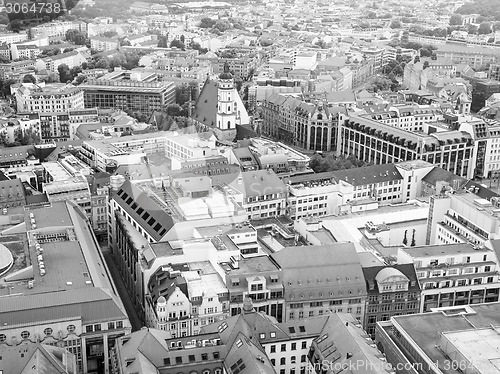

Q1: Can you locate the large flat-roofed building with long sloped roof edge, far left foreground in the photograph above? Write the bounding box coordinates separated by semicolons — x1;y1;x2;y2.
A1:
0;202;131;374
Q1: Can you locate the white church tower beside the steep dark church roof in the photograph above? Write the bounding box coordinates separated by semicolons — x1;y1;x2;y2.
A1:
216;62;238;139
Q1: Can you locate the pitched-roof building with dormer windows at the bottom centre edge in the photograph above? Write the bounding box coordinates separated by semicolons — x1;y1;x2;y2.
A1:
112;302;384;374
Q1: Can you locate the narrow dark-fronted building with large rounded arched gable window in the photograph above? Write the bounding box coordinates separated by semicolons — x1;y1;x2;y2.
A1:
363;264;420;339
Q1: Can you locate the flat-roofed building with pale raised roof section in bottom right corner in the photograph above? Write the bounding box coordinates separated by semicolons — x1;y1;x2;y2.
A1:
376;303;500;374
